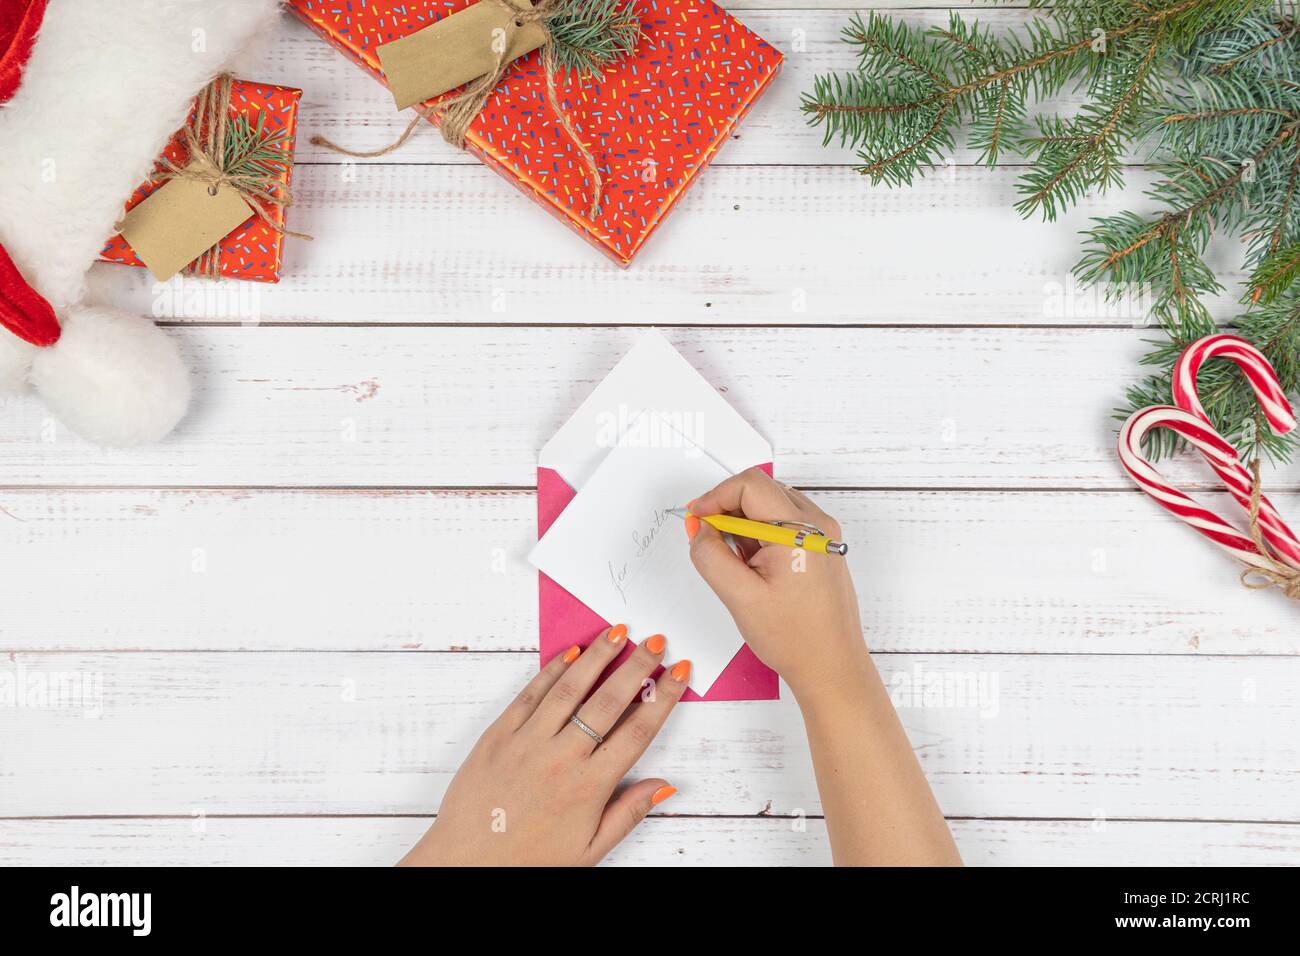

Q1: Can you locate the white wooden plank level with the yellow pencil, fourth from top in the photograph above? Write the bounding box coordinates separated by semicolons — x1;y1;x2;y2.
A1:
0;490;1300;654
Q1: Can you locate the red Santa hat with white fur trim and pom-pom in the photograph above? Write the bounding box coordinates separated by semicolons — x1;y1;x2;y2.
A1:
0;0;278;445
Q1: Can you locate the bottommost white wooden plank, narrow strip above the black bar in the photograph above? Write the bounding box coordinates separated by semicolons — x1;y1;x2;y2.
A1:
0;816;1300;866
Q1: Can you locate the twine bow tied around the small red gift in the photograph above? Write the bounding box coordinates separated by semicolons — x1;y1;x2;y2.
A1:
139;73;312;278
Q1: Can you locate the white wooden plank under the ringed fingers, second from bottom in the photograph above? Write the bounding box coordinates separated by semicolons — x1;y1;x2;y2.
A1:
0;650;1300;822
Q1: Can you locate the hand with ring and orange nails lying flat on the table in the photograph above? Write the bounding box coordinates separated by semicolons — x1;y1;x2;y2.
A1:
402;624;690;866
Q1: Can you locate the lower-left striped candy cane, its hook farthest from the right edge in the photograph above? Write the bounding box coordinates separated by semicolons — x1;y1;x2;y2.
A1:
1119;405;1274;570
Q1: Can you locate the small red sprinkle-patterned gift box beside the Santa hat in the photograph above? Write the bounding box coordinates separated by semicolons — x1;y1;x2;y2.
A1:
99;79;303;282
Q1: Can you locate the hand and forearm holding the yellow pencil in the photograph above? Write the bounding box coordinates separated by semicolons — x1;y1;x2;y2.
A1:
686;468;961;866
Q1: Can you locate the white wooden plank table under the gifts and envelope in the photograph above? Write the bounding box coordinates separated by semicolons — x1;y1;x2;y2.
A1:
0;0;1300;864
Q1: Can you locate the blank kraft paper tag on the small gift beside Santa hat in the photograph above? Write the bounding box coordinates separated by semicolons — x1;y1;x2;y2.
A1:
120;170;255;282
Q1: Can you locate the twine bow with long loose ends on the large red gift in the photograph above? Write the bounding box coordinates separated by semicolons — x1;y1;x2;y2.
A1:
311;0;605;219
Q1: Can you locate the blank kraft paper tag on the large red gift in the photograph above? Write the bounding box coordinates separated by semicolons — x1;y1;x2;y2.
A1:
376;0;546;109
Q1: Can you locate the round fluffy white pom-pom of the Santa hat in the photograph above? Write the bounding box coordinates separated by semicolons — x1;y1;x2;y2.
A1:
31;306;190;446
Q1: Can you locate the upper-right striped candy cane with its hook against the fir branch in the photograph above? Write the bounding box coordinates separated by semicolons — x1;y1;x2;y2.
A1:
1173;334;1300;568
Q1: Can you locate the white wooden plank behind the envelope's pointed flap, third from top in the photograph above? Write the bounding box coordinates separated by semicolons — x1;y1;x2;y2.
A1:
0;328;1300;490
